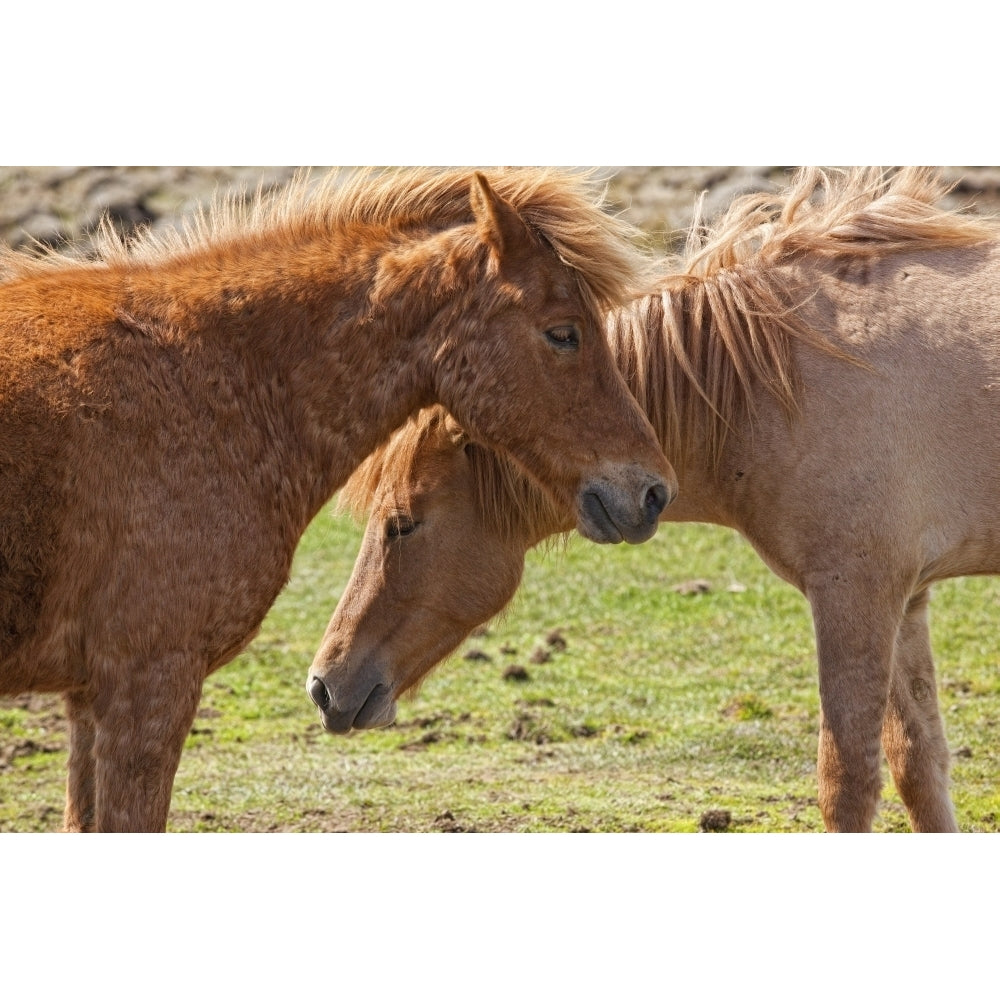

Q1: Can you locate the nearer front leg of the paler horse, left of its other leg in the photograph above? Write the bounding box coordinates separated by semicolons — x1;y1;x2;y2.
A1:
808;576;903;833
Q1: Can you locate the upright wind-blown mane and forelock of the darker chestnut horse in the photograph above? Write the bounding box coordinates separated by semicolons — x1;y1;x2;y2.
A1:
0;167;651;312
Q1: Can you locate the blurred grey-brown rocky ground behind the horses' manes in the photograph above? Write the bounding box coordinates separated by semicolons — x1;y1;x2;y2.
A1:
0;167;1000;256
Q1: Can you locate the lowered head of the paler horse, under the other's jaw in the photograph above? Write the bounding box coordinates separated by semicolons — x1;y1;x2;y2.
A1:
307;407;560;732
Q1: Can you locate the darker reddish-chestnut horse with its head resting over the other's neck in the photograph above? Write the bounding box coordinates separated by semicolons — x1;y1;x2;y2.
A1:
0;169;675;830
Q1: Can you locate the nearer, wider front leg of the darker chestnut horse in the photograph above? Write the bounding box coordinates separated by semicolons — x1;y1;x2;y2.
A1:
94;654;205;833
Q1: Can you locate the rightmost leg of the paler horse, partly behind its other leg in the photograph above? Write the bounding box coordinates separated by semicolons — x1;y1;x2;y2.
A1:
882;590;958;833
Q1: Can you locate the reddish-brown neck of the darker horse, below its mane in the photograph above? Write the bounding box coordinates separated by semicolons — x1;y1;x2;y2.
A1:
119;227;476;509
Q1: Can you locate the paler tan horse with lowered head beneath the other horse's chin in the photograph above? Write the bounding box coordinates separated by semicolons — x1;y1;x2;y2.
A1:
311;169;1000;830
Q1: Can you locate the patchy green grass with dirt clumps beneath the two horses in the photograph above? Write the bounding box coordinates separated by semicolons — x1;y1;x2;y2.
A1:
0;504;1000;832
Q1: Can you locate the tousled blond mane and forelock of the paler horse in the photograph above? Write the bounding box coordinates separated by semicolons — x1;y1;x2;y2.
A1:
342;167;1000;535
